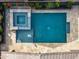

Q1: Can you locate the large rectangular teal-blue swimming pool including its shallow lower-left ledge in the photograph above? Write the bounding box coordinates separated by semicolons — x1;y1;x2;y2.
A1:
16;13;67;43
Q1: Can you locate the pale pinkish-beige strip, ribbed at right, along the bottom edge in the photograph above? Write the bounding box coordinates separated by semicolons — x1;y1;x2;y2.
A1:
1;52;79;59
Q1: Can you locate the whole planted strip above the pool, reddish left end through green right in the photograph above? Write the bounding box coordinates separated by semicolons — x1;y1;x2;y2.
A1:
0;1;73;9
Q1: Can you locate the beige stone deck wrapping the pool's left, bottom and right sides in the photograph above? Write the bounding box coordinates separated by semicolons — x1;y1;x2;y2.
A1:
2;6;79;53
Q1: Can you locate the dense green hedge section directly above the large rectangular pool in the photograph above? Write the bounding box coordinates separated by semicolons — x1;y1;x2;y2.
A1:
28;1;73;9
